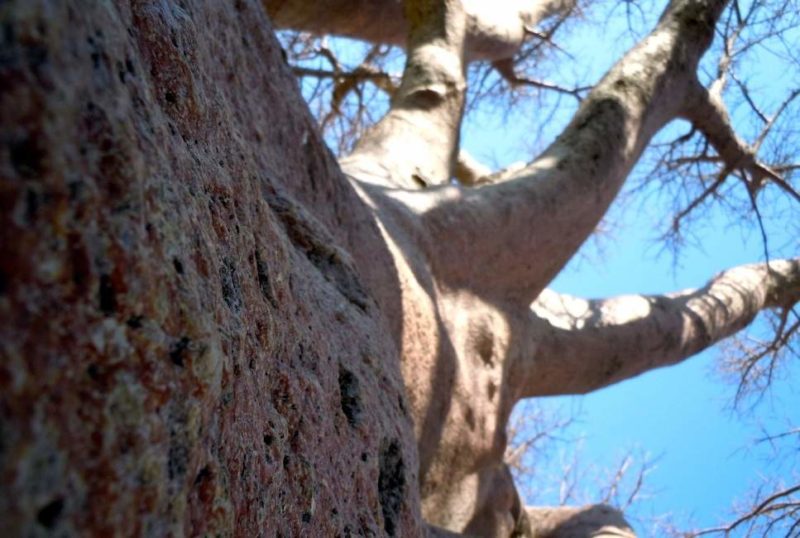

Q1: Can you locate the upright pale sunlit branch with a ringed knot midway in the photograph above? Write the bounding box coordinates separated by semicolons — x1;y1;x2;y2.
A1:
341;0;466;189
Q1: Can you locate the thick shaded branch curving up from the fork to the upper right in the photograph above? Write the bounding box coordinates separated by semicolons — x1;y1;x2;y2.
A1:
395;0;725;303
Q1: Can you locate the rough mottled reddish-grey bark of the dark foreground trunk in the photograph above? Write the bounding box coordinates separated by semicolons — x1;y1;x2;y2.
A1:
0;0;421;536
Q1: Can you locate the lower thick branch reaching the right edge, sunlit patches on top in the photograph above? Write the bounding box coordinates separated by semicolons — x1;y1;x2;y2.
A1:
521;258;800;397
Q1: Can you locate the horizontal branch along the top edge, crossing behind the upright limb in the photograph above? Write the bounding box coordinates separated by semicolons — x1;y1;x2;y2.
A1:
264;0;575;60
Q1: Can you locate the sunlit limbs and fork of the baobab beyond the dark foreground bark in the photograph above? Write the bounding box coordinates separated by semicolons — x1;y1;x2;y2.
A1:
265;1;798;536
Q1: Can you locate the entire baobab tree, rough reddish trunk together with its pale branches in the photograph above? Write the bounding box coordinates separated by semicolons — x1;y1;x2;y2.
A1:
0;0;800;536
